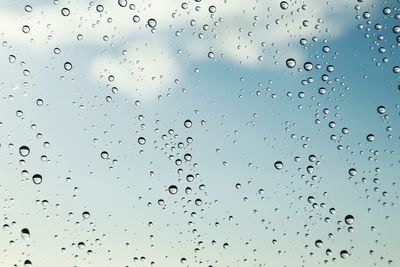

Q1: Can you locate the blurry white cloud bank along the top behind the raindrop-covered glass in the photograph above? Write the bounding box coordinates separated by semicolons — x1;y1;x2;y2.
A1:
0;0;362;96
